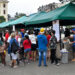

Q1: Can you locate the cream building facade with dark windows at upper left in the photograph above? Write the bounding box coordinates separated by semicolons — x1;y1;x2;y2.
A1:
0;0;8;21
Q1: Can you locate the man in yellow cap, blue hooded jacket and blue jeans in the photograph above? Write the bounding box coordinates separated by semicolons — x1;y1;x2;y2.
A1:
37;28;48;66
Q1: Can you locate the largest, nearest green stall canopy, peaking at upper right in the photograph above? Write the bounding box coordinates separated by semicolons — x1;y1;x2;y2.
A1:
25;3;75;25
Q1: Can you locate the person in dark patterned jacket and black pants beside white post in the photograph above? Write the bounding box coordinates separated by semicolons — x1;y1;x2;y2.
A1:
50;30;59;66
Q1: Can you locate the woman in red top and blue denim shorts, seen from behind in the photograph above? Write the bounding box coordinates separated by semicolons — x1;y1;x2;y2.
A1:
23;35;31;60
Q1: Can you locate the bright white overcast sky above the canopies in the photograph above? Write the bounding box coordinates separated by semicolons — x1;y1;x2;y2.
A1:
8;0;59;17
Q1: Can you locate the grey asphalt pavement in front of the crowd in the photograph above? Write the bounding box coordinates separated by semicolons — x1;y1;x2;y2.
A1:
0;54;75;75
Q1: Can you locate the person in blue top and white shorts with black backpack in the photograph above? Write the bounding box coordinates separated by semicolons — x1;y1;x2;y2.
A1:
9;33;19;68
